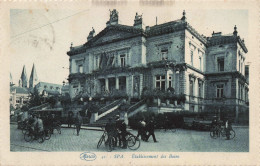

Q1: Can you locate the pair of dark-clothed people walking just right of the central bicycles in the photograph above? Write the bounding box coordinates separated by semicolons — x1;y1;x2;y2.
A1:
137;116;158;142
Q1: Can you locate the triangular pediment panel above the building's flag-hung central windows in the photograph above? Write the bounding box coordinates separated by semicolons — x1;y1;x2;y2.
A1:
92;29;136;45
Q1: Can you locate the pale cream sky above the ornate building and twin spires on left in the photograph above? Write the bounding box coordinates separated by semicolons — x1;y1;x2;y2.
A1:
9;6;250;85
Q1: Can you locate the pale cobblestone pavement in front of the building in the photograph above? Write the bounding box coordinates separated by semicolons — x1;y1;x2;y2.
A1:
10;124;249;152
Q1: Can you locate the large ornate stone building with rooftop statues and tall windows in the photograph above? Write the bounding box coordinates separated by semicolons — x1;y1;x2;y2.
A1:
67;10;249;117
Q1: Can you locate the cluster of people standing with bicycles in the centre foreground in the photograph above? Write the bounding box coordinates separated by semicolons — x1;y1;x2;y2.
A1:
105;116;127;149
